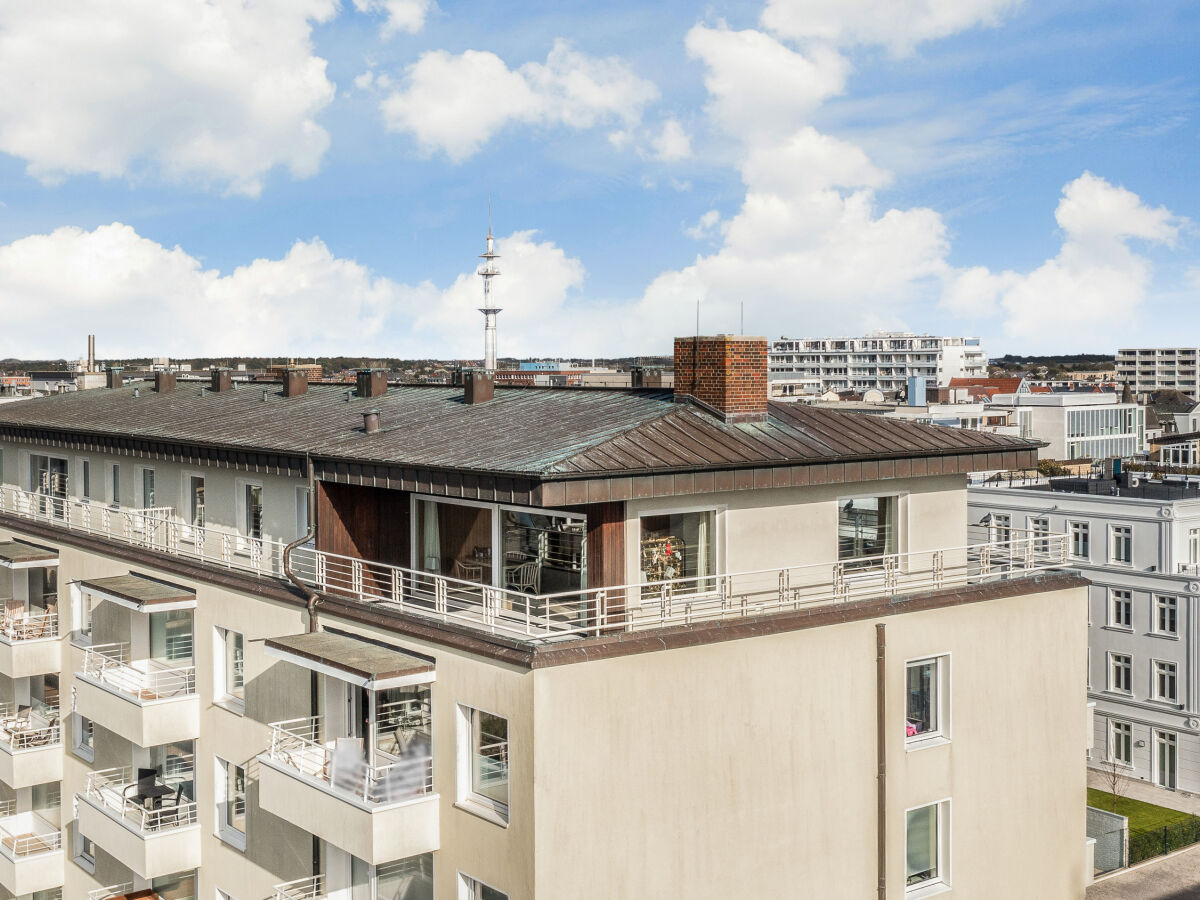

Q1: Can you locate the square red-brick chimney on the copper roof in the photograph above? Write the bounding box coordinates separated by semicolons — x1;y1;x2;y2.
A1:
674;335;767;422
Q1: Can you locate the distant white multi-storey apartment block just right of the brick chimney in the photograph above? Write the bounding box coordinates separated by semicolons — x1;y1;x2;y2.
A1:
769;331;988;400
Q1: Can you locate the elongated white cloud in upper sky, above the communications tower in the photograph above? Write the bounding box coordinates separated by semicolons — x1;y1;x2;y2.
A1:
379;40;659;161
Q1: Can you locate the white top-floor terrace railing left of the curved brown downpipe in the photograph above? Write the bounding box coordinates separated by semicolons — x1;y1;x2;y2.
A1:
0;485;287;577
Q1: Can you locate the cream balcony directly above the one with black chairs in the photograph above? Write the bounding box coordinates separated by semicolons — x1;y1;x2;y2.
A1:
76;643;200;746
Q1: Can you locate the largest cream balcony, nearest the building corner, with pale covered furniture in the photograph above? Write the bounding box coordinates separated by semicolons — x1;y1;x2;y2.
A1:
258;713;439;868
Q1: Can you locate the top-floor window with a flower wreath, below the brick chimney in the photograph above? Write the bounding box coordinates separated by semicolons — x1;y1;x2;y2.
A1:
641;510;716;593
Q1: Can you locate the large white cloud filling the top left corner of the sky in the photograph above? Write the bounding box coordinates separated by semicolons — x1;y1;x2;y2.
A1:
0;0;337;194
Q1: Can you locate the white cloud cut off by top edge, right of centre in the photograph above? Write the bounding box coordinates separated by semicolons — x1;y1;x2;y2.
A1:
762;0;1021;54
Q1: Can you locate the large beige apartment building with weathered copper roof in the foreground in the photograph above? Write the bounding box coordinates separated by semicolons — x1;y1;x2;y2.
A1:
0;336;1090;900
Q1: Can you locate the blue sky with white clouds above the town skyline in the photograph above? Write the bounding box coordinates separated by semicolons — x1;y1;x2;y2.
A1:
0;0;1200;359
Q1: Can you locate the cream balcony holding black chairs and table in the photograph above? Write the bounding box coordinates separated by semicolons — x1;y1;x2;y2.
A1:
76;767;200;878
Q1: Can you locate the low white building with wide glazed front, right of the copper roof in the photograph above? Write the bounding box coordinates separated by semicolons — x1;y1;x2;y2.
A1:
991;394;1146;460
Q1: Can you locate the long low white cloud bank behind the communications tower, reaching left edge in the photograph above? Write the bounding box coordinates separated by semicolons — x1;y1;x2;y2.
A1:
0;223;599;359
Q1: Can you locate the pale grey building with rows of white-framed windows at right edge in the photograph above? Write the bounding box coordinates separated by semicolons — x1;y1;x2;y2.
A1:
970;473;1200;792
